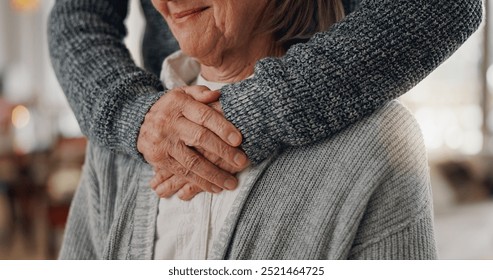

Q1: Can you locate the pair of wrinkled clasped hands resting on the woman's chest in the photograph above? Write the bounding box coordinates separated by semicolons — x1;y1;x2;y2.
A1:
137;86;249;200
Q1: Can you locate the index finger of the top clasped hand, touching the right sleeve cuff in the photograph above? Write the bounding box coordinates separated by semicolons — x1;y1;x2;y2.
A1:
182;99;242;147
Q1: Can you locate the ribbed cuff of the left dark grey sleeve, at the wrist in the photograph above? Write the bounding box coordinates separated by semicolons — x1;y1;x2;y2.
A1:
110;86;164;162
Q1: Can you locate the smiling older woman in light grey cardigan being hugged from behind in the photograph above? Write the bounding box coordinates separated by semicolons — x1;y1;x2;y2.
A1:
60;0;436;259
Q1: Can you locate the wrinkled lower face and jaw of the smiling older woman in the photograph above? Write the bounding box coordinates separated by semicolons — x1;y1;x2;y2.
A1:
153;0;274;83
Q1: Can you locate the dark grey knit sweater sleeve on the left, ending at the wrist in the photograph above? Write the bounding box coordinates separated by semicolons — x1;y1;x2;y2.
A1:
48;0;163;157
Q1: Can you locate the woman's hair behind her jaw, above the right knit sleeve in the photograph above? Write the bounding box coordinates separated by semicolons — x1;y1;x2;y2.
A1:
259;0;344;51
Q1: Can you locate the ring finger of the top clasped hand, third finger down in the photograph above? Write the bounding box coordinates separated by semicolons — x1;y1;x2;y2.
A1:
170;143;238;191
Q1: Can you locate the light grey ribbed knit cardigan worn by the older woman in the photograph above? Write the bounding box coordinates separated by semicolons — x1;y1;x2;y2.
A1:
60;101;436;259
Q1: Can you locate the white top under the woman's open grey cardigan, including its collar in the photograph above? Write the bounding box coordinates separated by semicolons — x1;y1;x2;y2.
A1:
154;51;249;260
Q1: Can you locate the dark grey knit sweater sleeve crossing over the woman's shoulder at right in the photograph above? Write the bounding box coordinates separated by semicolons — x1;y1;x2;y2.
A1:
221;0;482;163
